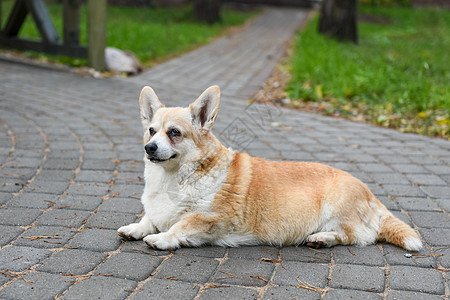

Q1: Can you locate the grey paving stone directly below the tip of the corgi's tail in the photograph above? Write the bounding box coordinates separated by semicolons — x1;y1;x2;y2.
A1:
383;244;436;267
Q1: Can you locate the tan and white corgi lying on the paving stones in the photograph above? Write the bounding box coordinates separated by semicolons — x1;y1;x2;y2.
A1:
118;86;422;251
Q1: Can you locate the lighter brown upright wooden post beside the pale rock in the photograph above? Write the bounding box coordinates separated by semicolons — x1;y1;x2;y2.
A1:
87;0;106;71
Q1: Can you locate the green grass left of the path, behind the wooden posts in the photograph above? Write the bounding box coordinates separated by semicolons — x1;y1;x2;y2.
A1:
2;1;259;66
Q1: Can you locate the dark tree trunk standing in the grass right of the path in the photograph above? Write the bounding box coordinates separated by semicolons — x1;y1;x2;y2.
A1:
319;0;358;43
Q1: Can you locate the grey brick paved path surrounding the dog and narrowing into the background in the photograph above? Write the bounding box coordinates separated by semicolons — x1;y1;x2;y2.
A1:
0;9;450;299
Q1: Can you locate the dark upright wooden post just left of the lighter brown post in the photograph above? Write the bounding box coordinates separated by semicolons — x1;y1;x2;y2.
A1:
63;0;80;46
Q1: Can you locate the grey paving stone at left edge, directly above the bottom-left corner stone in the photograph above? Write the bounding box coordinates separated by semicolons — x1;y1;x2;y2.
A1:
0;246;51;272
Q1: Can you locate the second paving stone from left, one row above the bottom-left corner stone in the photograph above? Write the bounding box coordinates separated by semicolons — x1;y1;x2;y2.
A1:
37;249;106;275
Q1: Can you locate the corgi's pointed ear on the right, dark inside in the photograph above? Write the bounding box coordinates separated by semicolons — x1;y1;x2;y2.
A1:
189;85;220;130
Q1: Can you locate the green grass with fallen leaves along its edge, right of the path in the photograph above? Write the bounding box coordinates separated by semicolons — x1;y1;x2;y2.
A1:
288;7;450;138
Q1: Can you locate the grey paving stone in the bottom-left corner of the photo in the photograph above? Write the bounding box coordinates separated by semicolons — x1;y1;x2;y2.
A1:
0;272;75;299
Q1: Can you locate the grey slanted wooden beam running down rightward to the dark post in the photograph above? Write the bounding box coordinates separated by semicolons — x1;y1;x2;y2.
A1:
26;0;60;43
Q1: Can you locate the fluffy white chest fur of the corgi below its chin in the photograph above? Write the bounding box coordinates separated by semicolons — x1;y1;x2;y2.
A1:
142;157;229;232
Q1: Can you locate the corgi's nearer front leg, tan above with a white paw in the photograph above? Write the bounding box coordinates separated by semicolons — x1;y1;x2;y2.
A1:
144;213;220;250
